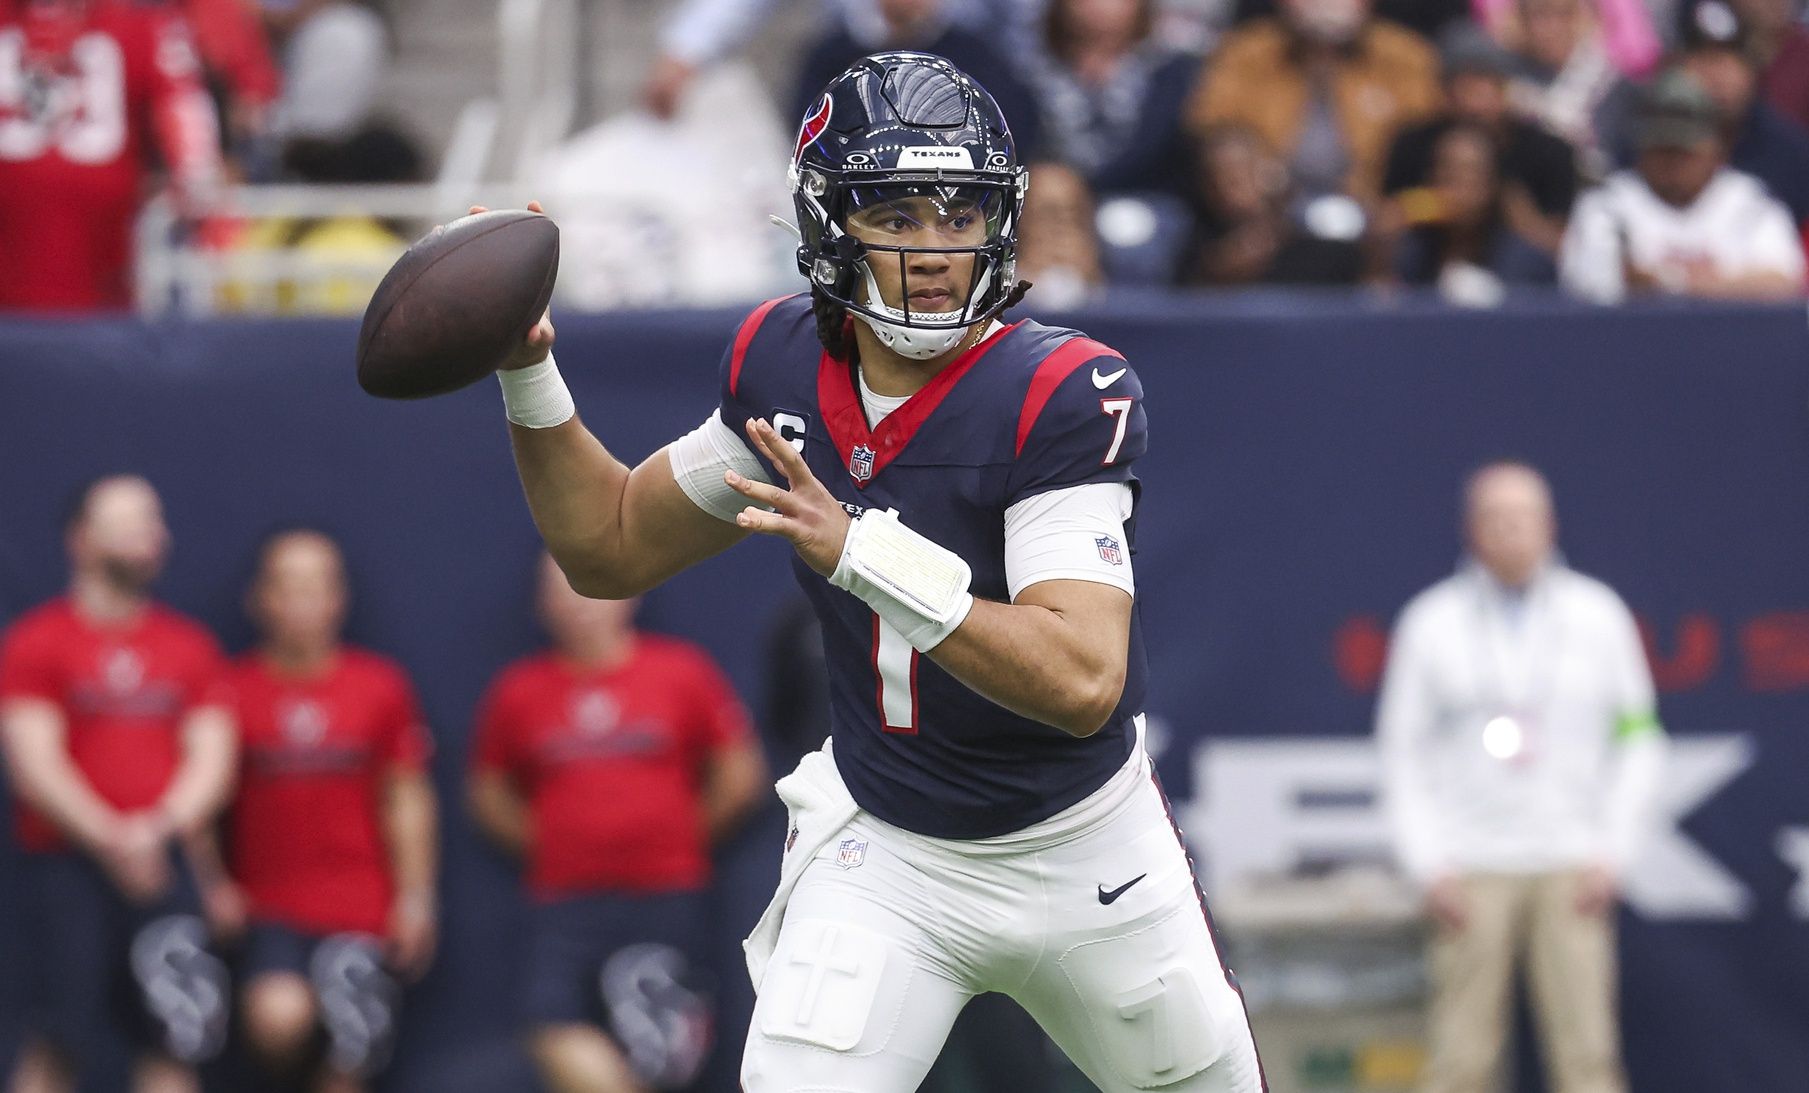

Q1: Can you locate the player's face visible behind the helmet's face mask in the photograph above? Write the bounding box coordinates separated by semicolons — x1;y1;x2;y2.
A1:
848;186;997;315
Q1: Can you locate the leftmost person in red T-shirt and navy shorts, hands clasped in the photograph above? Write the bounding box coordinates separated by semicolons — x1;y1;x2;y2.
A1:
0;476;233;1093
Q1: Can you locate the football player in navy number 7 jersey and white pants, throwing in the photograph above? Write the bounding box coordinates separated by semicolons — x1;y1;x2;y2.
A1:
477;52;1263;1093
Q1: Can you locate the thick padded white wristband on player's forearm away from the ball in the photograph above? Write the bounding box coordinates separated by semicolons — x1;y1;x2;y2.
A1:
829;508;973;653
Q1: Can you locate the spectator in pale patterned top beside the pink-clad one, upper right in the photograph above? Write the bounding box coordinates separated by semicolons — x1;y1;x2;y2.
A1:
1507;0;1634;179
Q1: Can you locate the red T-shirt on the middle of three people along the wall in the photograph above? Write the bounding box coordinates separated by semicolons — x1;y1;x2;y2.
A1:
232;648;429;934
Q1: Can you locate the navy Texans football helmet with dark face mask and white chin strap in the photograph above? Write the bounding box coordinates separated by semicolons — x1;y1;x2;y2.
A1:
791;52;1029;358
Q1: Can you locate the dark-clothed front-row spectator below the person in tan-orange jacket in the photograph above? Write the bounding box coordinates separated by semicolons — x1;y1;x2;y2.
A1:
1179;127;1364;286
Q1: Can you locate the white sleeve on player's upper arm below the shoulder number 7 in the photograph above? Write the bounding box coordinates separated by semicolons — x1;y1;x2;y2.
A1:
1006;481;1136;601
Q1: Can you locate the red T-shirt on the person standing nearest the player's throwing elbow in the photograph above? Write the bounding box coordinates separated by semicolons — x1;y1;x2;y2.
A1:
472;635;749;899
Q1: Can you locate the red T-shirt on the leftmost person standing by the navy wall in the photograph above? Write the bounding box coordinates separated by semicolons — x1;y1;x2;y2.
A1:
0;599;228;852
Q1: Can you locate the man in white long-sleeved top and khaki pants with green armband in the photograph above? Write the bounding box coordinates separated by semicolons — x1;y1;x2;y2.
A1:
1377;461;1666;1093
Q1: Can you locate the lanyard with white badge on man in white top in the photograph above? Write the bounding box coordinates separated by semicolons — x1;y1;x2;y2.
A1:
1474;577;1563;769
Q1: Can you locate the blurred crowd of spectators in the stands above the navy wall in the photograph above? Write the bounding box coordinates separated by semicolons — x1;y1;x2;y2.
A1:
0;0;1809;309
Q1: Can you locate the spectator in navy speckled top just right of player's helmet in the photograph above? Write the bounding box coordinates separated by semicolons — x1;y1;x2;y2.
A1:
1034;0;1199;197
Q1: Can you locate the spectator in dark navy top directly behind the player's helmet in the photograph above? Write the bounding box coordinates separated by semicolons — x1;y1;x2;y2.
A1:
787;0;1042;156
